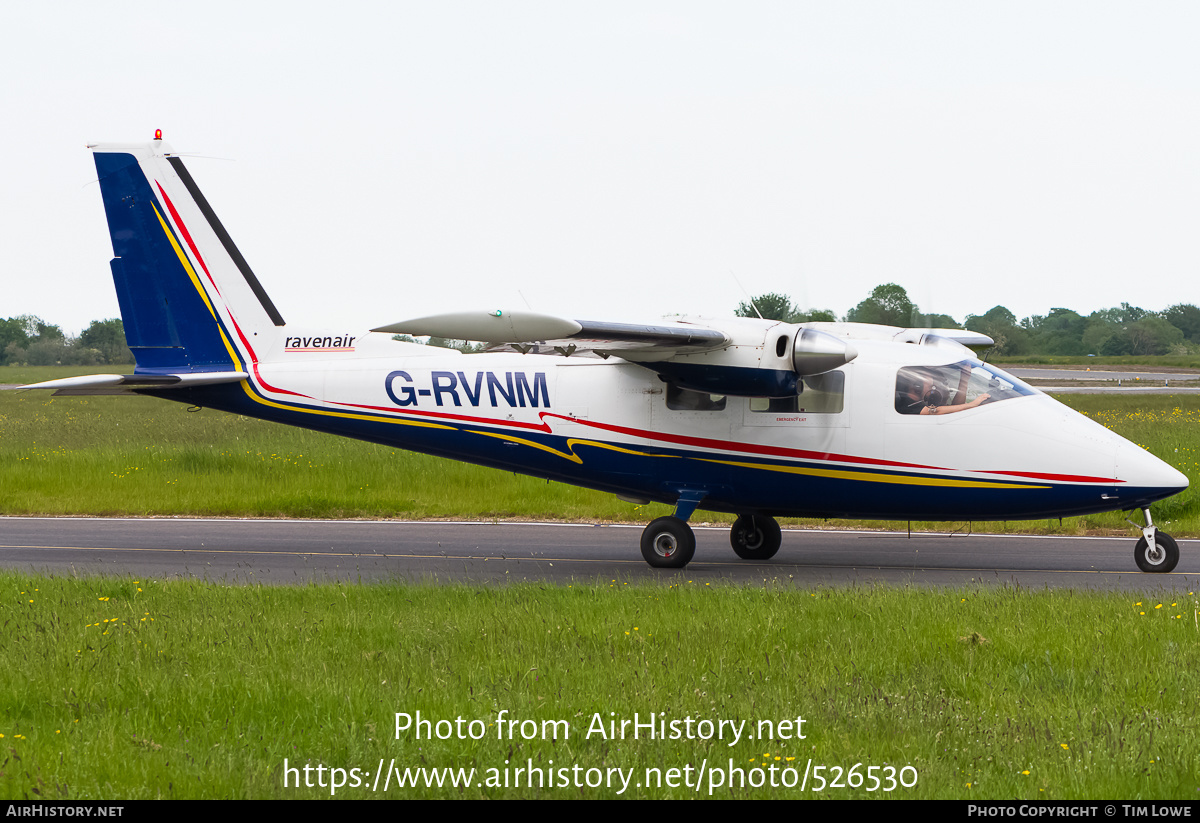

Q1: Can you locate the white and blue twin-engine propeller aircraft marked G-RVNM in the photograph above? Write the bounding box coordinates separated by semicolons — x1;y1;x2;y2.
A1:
21;133;1188;572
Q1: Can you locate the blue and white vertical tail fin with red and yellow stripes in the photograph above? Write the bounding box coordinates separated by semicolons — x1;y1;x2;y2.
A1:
89;139;283;373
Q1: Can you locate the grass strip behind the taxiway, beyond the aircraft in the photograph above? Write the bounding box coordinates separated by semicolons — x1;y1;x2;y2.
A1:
0;368;1200;536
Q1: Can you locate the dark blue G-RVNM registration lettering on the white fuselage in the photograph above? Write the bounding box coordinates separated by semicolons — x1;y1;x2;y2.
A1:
384;371;550;409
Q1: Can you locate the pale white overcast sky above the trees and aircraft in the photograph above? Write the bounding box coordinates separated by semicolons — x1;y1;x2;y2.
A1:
0;0;1200;332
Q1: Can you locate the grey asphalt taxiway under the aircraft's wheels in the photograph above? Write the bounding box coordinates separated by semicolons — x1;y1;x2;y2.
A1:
0;517;1200;591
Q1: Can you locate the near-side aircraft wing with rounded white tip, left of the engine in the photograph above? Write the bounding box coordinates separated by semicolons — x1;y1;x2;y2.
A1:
371;311;730;361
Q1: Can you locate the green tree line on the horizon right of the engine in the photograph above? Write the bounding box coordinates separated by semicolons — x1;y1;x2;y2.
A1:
737;283;1200;356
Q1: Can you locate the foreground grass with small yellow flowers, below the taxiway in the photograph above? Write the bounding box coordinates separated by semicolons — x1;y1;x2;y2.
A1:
0;573;1200;800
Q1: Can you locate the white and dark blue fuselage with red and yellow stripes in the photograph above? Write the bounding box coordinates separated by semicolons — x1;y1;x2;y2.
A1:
189;331;1187;519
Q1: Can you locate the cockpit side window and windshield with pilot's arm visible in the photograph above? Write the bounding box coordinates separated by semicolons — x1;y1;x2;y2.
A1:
896;359;1037;414
